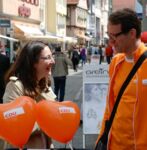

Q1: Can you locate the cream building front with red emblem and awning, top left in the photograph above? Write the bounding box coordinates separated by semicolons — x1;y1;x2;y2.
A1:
0;0;43;59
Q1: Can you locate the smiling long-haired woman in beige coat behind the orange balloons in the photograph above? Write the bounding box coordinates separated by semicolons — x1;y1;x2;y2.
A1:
3;41;56;149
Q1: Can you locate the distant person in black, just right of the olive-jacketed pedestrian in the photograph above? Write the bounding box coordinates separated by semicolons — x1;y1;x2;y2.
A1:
71;47;80;72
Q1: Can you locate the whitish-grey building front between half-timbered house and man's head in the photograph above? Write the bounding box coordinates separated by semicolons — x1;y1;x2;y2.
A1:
87;0;109;45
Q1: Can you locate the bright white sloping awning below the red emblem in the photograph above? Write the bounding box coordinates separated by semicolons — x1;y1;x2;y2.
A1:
14;24;43;37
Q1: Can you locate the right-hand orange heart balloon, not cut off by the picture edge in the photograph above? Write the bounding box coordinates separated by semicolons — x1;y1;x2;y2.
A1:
36;100;80;143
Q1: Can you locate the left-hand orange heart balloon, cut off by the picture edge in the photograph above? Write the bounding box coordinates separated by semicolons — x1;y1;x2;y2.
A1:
0;96;35;148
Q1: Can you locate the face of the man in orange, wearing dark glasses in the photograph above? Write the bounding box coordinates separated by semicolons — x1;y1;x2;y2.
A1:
107;22;130;53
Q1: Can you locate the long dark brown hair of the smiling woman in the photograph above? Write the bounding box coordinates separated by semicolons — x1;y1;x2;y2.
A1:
5;41;51;98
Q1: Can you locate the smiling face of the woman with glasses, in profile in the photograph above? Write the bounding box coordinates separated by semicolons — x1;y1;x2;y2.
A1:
35;46;55;81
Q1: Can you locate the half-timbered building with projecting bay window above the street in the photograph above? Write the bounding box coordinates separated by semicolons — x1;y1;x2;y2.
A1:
66;0;89;44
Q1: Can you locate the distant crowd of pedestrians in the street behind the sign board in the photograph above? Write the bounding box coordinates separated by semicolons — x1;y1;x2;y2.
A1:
69;44;114;71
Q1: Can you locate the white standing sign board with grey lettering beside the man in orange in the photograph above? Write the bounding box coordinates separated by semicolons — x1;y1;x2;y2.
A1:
83;64;109;134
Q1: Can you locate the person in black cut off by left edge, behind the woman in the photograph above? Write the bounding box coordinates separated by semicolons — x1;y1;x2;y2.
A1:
0;52;10;103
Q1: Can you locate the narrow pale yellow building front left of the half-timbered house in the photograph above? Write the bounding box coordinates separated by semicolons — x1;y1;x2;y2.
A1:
46;0;67;37
